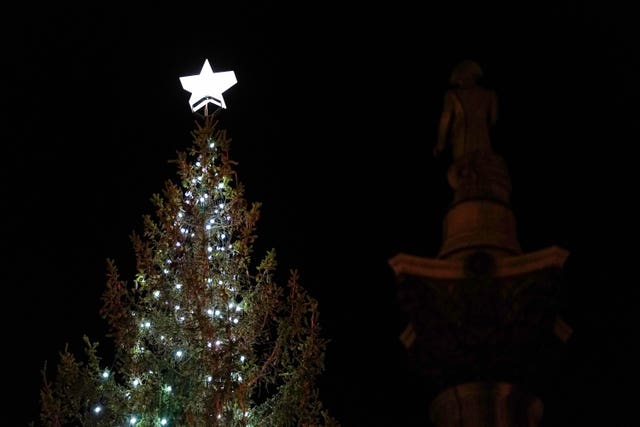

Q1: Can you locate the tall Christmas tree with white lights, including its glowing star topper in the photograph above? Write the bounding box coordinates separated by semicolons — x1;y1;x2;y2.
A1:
40;61;337;427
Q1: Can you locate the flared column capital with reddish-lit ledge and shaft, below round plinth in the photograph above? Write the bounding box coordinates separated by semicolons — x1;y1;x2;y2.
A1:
390;246;571;427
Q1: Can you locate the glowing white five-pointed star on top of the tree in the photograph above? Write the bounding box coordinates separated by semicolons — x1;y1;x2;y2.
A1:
180;59;237;111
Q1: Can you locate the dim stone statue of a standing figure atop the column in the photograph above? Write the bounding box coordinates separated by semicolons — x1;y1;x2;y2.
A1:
433;60;511;206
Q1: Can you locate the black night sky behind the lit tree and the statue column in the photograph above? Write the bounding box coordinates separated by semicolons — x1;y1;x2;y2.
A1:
1;1;640;427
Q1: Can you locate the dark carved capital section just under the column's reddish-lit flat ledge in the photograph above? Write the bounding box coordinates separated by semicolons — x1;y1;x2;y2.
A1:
398;266;562;379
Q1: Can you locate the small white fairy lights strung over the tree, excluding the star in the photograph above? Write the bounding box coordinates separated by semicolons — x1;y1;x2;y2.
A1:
93;136;248;426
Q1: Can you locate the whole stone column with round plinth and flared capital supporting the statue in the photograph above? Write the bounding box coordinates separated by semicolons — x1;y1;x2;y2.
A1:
396;139;571;427
